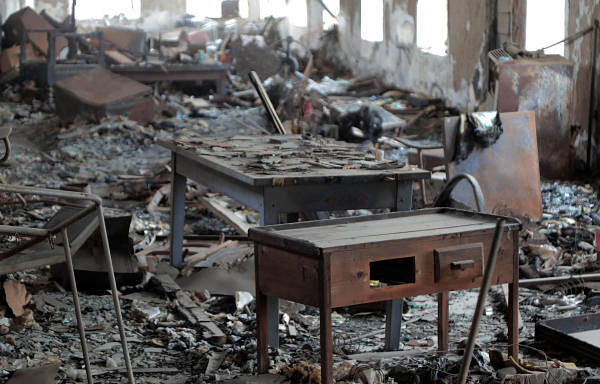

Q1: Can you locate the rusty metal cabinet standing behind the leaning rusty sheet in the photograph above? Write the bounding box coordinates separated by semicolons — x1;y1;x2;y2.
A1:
498;55;576;178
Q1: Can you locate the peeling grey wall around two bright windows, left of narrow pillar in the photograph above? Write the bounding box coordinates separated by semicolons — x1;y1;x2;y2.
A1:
330;0;495;108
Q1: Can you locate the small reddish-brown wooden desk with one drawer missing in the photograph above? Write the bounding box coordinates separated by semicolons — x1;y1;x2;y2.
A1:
249;208;521;383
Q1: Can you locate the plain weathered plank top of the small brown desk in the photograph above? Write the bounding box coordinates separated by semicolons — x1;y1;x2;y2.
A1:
248;208;520;254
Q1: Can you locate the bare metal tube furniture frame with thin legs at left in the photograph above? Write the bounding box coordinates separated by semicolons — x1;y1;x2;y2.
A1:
0;184;135;384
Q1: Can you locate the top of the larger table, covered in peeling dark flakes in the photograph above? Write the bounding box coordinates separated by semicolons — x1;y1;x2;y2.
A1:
159;135;430;186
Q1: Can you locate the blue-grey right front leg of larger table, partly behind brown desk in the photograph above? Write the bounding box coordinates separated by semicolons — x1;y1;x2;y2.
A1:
385;180;413;351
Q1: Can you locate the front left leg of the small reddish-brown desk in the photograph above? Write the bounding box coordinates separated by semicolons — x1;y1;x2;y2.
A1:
319;255;334;384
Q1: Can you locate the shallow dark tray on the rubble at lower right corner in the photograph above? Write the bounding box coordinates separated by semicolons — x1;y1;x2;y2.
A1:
535;313;600;362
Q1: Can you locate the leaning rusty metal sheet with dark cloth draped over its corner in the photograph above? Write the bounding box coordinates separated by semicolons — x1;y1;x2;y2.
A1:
444;111;542;220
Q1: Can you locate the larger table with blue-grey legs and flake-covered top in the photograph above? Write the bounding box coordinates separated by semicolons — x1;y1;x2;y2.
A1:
159;135;429;349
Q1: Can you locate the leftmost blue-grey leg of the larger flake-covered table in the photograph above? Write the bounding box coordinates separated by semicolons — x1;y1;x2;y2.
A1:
170;155;187;268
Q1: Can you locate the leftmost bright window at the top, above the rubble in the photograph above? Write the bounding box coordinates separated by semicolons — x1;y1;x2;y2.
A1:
69;0;142;20
